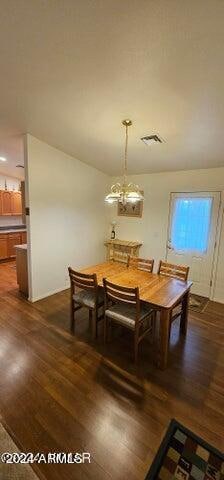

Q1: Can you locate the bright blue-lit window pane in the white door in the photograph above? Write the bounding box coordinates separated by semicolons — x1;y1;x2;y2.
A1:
171;196;213;253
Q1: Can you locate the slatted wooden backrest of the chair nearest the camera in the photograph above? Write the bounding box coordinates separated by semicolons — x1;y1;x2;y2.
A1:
103;278;140;318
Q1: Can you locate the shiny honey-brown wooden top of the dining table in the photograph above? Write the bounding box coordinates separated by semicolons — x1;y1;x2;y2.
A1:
81;262;192;308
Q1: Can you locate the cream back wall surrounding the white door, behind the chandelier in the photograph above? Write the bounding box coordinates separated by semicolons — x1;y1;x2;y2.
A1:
108;168;224;303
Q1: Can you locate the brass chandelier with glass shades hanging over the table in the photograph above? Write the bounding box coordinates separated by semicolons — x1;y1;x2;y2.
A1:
105;120;144;205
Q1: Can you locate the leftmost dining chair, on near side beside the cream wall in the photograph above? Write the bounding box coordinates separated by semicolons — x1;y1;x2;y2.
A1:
68;267;104;339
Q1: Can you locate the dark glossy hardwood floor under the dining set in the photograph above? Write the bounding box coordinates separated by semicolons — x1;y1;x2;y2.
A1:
0;263;224;480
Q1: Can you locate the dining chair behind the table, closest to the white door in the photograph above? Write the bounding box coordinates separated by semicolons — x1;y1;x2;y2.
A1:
158;260;189;337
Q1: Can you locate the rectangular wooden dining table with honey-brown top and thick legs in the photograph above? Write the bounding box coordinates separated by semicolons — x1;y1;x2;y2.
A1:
81;261;192;370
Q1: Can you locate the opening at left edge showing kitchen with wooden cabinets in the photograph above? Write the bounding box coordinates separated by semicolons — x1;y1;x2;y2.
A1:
0;135;28;297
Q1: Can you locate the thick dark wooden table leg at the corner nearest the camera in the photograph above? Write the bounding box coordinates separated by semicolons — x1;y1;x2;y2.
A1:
158;308;170;370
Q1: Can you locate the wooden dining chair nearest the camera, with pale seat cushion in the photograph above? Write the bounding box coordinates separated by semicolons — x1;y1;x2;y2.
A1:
103;278;154;363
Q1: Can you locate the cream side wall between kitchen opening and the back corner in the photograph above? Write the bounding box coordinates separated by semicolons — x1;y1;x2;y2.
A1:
25;135;108;301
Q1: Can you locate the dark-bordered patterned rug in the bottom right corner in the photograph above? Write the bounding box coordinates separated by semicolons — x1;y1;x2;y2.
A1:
145;420;224;480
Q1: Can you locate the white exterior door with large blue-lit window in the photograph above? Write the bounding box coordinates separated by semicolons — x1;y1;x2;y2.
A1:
167;192;221;297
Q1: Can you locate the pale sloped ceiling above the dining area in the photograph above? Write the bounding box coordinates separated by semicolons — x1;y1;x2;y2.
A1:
0;0;224;174
